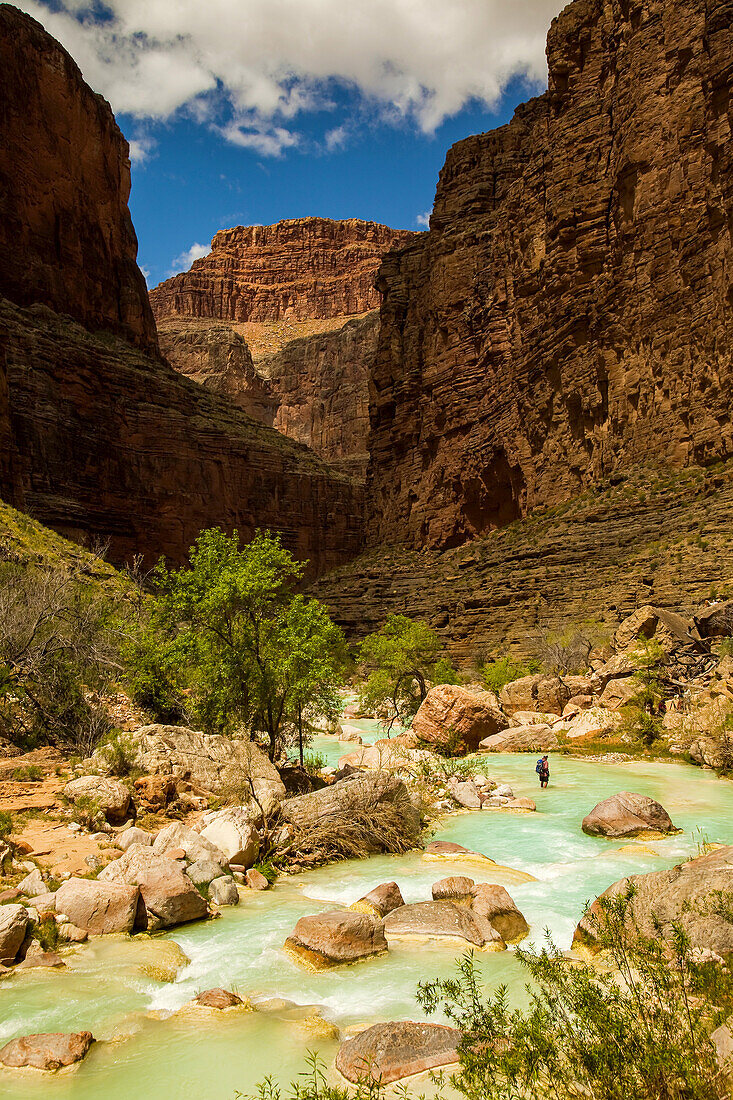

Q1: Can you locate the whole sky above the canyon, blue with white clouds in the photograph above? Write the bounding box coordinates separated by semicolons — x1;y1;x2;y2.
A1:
15;0;564;286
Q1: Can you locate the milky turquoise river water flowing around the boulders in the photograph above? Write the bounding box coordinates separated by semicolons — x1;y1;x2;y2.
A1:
0;748;733;1100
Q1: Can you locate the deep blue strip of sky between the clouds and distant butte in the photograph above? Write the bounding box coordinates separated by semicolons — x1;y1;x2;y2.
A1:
118;81;530;286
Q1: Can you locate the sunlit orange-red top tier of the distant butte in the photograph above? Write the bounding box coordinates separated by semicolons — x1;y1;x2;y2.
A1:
150;218;414;321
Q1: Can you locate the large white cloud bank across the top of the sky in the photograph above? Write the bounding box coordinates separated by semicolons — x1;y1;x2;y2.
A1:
17;0;564;148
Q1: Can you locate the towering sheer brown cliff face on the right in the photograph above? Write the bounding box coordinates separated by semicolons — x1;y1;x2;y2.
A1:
368;0;733;548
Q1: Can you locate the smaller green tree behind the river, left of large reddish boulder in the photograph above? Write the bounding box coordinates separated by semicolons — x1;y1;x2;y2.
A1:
359;615;458;730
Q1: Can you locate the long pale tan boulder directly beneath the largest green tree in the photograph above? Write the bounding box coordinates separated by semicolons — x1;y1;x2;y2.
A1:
94;725;285;799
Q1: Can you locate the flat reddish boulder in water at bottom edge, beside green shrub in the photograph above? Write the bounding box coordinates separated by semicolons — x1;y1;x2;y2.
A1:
336;1020;461;1085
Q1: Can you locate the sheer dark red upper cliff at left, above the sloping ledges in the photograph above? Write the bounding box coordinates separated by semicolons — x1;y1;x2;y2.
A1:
0;4;156;353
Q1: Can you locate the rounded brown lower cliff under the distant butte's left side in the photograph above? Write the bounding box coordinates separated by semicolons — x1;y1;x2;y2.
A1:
157;321;277;424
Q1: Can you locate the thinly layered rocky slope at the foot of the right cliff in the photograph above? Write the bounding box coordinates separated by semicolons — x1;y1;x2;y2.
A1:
314;462;733;662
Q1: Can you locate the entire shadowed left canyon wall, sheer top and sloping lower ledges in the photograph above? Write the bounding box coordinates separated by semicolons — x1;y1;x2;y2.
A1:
0;4;362;573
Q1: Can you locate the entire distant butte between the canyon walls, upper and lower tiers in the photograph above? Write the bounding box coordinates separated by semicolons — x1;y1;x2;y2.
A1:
150;218;407;481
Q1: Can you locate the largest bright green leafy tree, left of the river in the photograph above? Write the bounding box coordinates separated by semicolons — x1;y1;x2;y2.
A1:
130;528;344;760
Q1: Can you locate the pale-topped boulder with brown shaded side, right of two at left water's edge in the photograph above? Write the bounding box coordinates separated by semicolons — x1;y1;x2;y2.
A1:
98;844;208;932
